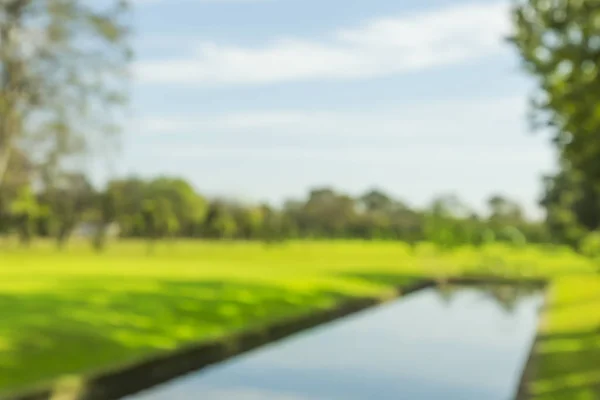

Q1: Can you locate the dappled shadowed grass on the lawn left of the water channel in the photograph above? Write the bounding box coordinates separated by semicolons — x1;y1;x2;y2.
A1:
0;280;340;392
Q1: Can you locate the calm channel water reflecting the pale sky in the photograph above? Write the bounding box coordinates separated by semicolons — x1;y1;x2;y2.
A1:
130;287;541;400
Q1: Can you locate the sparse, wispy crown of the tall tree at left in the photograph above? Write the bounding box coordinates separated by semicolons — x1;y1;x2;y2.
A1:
0;0;131;186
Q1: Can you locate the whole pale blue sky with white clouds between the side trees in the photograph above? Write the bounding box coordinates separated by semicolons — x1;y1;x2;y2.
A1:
102;0;554;217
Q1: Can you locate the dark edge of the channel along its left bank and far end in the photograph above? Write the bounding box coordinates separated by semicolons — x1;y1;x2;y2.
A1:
0;277;545;400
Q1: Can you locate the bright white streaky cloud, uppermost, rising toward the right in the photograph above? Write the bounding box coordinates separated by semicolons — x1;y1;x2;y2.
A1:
135;0;510;85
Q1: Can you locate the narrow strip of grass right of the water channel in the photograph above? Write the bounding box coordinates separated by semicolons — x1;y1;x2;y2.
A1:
530;277;600;400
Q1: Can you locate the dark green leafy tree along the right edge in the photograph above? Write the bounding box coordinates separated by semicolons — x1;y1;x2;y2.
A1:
511;0;600;250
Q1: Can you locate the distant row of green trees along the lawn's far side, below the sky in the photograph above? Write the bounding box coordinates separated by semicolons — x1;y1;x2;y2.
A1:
0;170;549;250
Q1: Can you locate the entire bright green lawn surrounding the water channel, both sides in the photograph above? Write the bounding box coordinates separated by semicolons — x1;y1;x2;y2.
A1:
0;241;600;399
